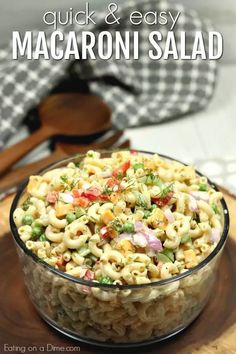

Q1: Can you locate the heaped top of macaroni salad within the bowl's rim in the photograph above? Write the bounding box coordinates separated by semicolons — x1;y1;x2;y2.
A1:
14;151;223;285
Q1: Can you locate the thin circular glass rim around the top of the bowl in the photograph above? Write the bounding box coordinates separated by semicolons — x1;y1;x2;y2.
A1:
9;149;230;290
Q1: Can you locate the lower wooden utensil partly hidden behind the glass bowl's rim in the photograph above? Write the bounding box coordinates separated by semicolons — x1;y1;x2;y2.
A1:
0;131;129;193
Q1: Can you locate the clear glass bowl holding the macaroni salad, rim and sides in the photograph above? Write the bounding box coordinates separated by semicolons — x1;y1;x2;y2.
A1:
10;152;229;347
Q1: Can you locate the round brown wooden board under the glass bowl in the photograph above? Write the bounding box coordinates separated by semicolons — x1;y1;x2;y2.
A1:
0;189;236;354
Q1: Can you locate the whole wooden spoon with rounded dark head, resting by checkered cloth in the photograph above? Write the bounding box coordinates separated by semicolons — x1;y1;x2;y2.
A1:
0;93;111;175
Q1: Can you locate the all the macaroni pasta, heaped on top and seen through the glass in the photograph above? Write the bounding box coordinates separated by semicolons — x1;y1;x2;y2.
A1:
13;151;226;343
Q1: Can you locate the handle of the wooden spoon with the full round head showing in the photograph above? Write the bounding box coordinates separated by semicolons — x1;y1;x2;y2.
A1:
0;127;53;175
